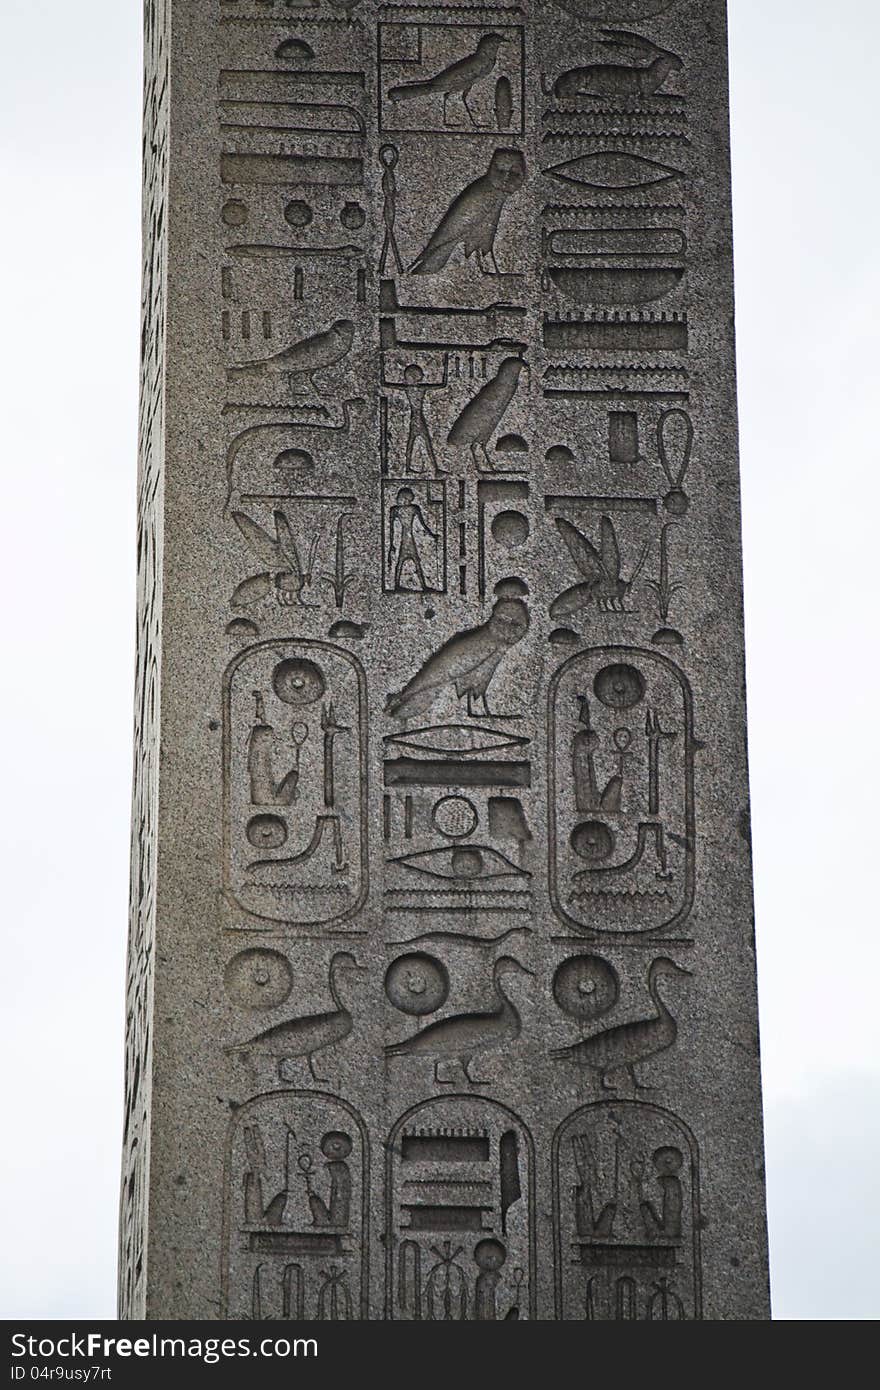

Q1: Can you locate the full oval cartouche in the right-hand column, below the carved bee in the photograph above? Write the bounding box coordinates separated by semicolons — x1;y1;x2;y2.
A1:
548;646;695;933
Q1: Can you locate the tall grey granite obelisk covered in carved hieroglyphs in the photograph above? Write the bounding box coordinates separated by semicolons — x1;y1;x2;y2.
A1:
121;0;769;1321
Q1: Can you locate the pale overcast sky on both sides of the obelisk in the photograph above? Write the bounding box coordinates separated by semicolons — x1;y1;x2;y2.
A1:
0;0;880;1319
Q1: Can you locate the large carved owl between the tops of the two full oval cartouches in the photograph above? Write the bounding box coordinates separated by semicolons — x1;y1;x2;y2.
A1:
385;580;528;719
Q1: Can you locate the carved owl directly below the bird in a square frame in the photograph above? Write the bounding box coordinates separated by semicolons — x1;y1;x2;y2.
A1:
410;149;525;275
